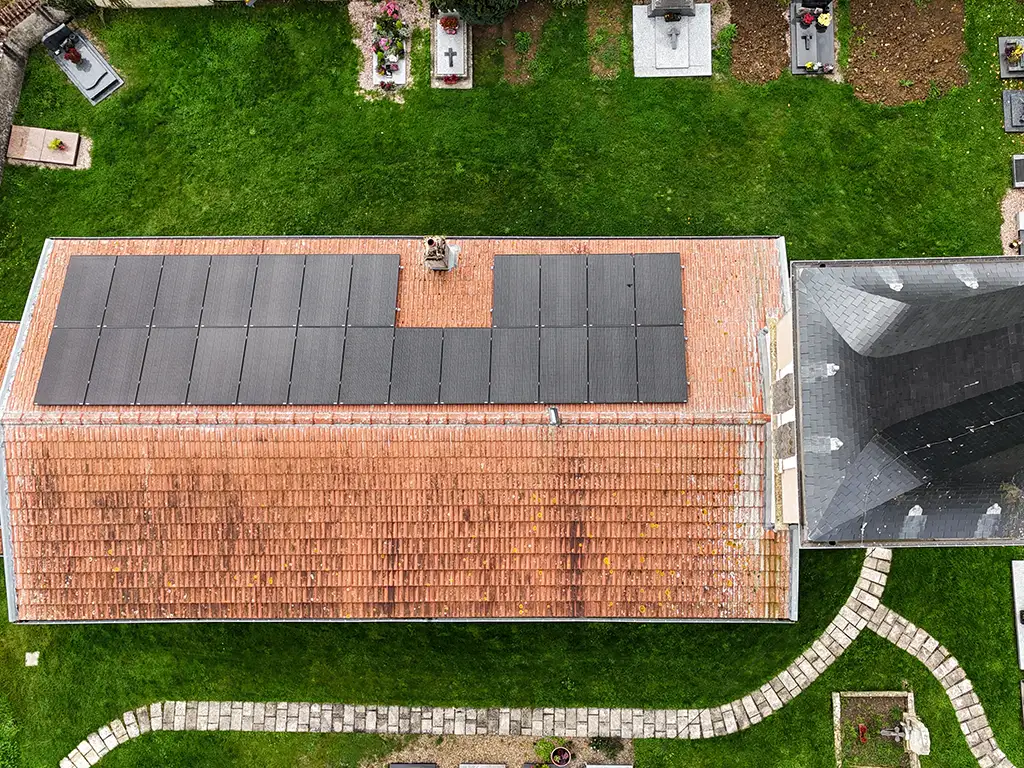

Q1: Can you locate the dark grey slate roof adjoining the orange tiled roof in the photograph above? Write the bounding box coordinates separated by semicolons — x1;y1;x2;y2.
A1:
793;257;1024;544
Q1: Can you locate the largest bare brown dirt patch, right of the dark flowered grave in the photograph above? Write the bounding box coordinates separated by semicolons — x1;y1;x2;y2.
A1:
846;0;967;105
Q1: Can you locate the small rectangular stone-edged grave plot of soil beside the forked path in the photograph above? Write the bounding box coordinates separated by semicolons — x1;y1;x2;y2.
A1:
833;691;920;768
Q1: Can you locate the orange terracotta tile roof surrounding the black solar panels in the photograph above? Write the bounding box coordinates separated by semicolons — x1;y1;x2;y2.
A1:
0;239;790;621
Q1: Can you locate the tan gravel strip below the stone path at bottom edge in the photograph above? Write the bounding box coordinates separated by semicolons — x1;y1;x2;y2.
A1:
372;736;633;768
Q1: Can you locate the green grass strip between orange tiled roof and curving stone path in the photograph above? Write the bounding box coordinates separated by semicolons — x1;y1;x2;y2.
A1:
0;552;861;768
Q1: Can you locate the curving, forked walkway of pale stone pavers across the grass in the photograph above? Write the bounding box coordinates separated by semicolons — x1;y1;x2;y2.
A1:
60;548;1014;768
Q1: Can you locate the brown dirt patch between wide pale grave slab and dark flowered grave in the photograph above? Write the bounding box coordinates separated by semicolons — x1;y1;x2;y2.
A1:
730;0;790;83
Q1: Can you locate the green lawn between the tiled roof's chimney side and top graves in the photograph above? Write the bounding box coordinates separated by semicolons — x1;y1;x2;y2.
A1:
0;0;1024;317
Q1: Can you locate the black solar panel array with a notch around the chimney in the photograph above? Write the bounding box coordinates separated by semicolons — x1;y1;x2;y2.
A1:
36;254;686;406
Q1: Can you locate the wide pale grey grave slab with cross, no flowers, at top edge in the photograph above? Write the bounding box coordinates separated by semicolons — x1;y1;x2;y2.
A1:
633;3;712;78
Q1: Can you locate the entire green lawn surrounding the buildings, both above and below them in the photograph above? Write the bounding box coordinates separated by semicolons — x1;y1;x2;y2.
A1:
6;0;1024;768
